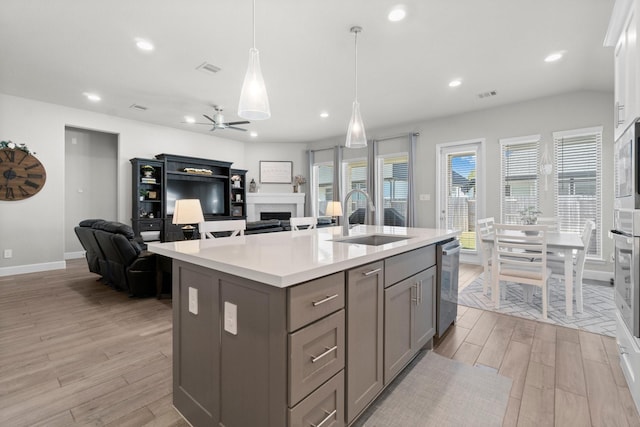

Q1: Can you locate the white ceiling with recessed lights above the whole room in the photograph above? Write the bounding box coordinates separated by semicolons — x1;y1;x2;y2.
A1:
0;0;614;142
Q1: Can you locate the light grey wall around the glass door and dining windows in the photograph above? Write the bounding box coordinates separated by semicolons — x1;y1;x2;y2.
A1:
309;91;613;271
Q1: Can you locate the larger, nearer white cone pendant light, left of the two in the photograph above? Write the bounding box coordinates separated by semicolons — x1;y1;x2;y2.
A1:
238;0;271;120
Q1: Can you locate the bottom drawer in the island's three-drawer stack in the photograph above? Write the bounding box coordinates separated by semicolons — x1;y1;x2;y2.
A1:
289;371;344;427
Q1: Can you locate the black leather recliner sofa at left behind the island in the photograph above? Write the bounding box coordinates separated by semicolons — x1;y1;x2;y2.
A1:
74;219;156;297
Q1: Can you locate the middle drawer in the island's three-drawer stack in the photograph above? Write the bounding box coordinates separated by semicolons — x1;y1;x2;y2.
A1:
289;310;344;406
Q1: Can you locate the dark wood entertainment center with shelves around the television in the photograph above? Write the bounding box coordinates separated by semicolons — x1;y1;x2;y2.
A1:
130;153;247;242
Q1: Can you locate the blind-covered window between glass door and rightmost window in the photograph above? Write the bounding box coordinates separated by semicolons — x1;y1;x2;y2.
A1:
500;135;540;224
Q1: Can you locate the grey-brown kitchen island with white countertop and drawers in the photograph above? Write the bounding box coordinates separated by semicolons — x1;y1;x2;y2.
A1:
149;226;457;427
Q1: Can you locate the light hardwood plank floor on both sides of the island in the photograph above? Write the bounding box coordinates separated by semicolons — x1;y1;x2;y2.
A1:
0;260;640;427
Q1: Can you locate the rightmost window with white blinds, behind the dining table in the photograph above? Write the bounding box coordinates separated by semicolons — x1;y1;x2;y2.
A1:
553;127;602;259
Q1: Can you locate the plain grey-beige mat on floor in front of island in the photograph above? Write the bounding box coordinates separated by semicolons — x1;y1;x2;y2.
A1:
354;351;512;427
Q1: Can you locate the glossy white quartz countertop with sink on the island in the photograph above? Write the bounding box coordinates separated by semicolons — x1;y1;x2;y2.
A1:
148;225;458;288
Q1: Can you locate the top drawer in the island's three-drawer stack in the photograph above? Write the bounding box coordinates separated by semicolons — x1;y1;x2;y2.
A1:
288;272;344;332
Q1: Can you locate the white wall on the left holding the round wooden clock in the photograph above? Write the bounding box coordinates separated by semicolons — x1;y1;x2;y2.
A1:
0;94;245;276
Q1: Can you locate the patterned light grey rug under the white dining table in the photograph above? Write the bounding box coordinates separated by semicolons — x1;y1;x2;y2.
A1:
458;276;616;337
